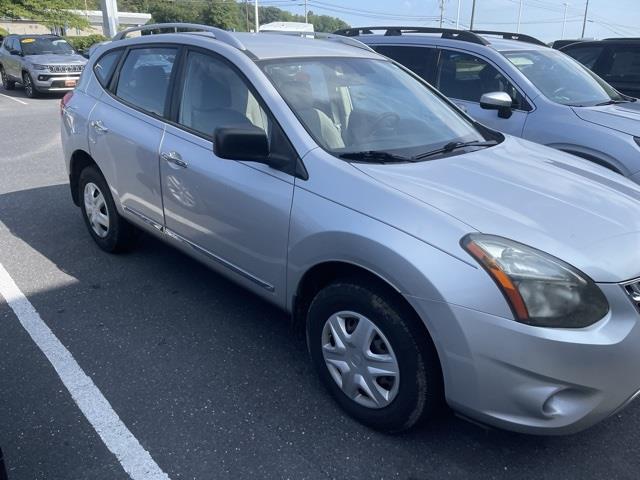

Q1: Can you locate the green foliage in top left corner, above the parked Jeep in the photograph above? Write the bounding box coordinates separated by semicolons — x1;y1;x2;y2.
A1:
0;0;89;28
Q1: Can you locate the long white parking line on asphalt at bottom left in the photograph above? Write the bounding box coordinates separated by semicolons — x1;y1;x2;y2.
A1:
0;264;169;480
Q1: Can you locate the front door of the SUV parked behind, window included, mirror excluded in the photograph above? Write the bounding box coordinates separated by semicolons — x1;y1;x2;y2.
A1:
435;49;531;137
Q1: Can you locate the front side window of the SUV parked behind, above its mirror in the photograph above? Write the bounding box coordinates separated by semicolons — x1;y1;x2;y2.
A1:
436;50;526;109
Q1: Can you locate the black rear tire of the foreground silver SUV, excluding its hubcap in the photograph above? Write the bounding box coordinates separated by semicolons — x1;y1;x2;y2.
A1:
78;165;138;253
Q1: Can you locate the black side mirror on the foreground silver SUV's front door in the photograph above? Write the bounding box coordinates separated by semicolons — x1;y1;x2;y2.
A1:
213;125;271;165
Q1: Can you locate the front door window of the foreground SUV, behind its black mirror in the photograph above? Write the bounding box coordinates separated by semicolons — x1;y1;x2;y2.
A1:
178;52;268;137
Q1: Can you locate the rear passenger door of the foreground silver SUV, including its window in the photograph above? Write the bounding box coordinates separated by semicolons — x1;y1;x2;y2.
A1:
89;46;178;228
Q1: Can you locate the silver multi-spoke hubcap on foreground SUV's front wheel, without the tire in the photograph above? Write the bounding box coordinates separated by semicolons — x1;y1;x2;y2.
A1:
322;312;400;408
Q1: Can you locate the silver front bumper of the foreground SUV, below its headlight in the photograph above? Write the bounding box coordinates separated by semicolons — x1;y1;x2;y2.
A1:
411;284;640;434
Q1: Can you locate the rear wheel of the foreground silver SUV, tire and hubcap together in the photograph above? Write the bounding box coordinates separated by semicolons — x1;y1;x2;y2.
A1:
78;166;137;253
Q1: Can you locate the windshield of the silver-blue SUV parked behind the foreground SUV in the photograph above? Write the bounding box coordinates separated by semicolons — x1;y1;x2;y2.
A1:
504;49;625;107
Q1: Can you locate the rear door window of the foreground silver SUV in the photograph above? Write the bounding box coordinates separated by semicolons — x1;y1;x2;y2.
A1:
116;47;177;115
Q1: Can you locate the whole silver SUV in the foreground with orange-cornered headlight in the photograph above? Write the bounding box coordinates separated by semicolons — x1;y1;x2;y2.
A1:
61;25;640;433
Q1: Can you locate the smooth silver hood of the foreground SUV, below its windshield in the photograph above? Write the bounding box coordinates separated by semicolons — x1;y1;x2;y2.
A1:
354;137;640;282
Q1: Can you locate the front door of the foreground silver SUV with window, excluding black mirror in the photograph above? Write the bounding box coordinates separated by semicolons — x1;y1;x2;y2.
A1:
160;50;295;305
